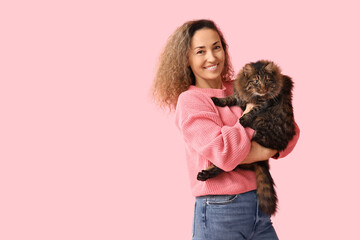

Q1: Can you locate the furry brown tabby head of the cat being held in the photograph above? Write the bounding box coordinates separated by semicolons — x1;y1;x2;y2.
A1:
235;60;283;100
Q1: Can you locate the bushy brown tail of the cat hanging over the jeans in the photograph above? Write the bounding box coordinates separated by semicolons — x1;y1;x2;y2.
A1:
255;160;278;215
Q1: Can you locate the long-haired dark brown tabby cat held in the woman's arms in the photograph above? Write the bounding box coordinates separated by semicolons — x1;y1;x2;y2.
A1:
198;60;295;215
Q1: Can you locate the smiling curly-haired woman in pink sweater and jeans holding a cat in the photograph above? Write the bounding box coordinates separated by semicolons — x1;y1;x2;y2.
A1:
154;20;299;240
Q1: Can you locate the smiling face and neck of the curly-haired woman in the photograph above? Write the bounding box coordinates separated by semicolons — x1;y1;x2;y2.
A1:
189;28;225;88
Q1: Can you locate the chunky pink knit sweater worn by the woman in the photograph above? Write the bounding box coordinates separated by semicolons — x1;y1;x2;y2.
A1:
175;82;300;196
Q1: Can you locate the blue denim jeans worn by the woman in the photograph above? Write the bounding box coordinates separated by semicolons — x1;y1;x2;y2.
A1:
192;191;278;240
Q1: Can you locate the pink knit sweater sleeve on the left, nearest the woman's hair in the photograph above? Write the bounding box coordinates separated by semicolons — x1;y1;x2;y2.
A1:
175;91;251;171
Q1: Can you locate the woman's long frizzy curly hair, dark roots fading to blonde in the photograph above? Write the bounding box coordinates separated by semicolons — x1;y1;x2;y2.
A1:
152;19;234;111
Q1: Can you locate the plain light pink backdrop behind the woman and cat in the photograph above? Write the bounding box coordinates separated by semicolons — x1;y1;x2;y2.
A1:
0;0;360;240
